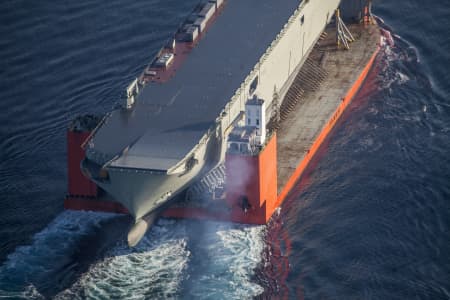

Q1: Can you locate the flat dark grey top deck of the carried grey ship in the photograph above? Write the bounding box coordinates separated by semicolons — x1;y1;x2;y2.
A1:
89;0;301;169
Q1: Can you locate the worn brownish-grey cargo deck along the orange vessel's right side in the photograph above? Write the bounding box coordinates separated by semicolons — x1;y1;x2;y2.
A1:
277;25;380;193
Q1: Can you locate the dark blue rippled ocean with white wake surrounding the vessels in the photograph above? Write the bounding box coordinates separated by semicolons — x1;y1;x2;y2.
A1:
0;0;450;299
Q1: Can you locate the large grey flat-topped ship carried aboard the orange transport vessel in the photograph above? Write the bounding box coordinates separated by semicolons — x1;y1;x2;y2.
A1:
69;0;380;245
